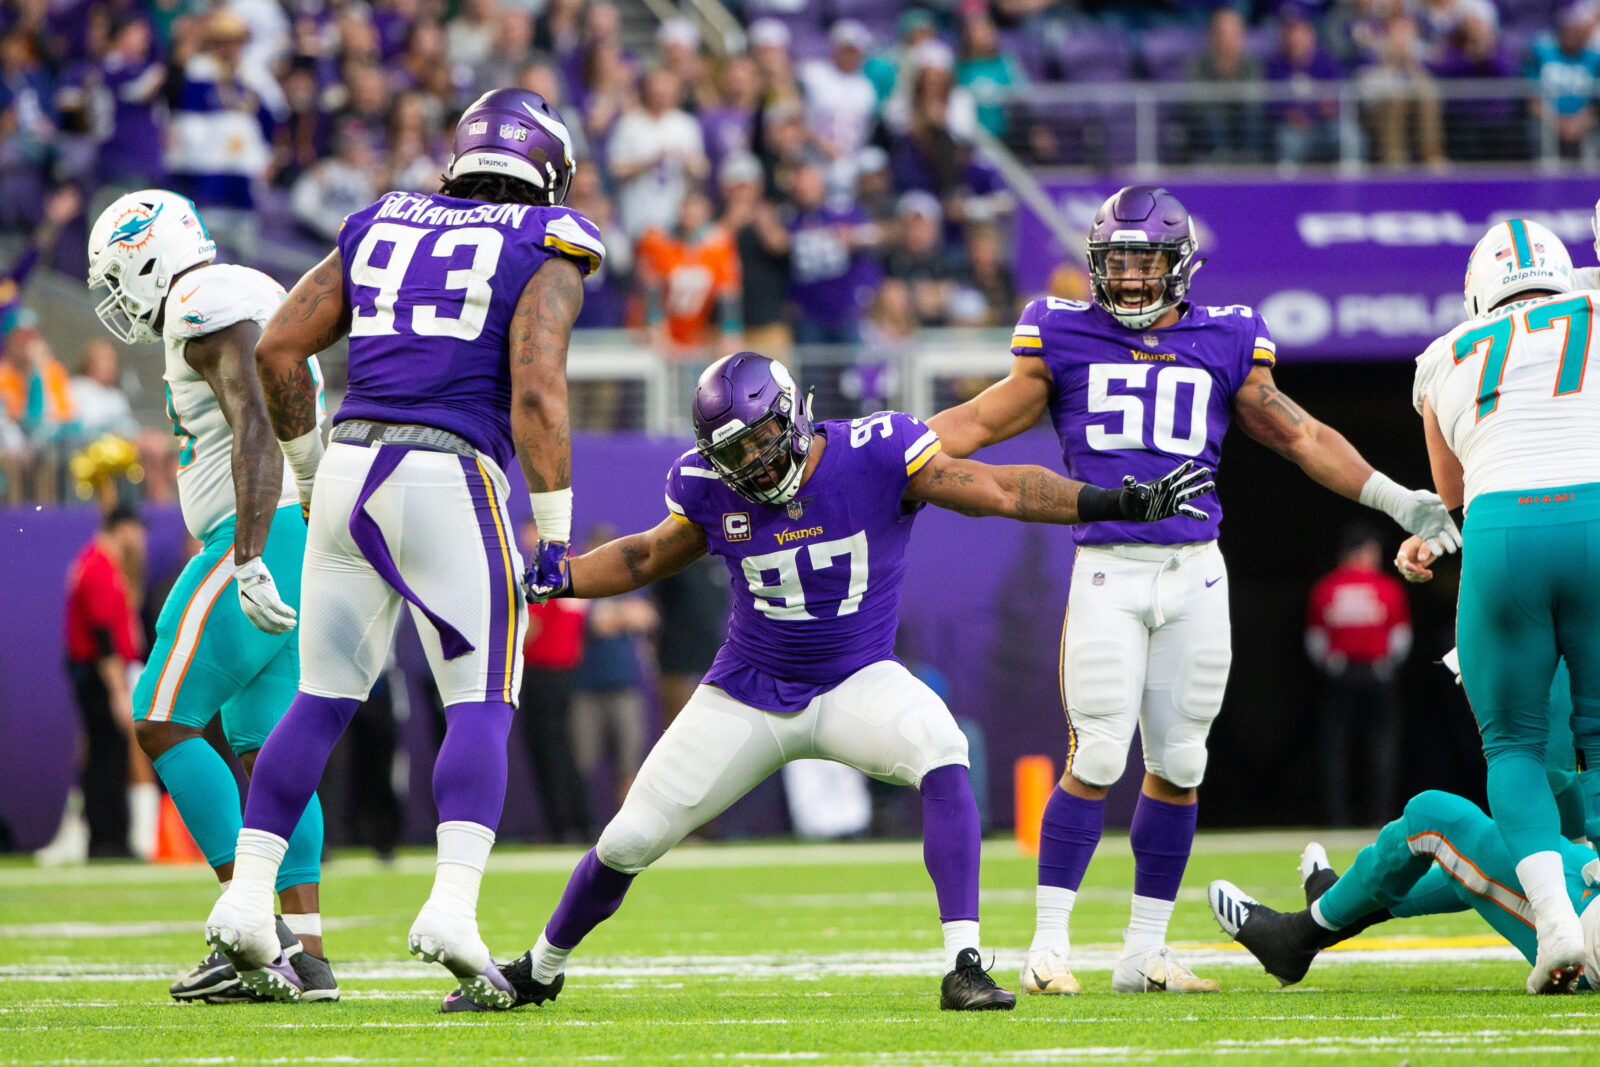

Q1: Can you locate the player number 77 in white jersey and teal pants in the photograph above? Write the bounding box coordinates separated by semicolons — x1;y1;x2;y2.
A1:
1397;219;1600;993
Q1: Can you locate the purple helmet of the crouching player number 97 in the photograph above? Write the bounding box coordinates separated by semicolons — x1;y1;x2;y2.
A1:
694;352;811;504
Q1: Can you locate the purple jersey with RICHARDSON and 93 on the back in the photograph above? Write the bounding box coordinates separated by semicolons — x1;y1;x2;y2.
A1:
333;192;605;469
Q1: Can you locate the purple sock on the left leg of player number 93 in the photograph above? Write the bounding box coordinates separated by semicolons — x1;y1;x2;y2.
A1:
245;693;358;840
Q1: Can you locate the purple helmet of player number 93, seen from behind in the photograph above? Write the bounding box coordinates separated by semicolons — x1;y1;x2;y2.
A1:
445;90;578;206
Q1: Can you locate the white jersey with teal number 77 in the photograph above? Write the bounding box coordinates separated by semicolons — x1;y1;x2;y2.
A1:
1411;290;1600;504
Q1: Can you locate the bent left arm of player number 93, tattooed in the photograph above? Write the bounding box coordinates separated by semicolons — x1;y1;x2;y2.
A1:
256;248;350;442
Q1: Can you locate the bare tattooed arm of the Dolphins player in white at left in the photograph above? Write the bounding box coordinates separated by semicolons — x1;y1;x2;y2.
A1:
184;318;283;565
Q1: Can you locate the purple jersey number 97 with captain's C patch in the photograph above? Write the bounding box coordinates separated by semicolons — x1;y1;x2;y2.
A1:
667;411;939;712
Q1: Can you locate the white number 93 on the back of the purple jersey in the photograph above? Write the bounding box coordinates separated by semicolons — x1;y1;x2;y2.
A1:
350;222;506;341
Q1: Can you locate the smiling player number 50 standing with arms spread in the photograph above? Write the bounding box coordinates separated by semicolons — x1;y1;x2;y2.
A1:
928;186;1459;993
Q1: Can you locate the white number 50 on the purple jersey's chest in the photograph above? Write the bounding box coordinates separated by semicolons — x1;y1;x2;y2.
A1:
1083;363;1211;456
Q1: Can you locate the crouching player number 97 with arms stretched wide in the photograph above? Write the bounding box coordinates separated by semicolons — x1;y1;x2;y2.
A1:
445;352;1211;1011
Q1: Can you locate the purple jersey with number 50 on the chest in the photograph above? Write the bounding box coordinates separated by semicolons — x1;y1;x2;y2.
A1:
1011;298;1277;544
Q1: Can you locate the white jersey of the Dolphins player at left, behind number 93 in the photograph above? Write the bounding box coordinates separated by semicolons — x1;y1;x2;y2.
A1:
162;264;323;541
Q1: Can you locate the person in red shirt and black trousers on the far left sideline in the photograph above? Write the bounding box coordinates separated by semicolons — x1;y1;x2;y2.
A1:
66;506;144;857
